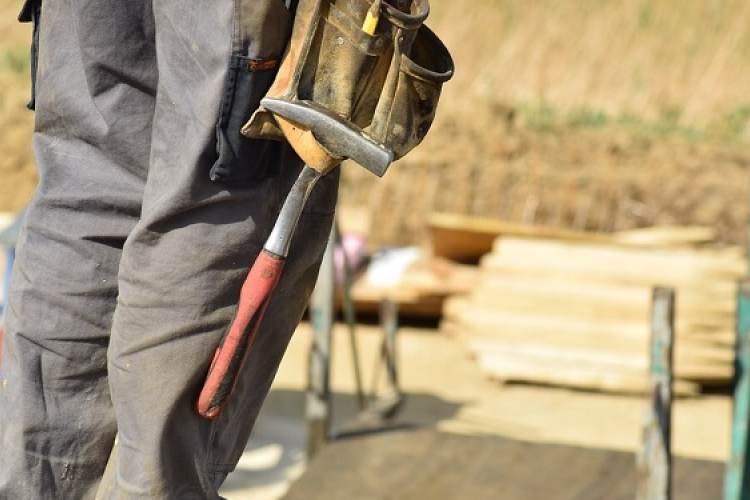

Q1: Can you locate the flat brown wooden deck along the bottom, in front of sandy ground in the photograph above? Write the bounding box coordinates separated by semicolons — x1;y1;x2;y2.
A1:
284;430;724;500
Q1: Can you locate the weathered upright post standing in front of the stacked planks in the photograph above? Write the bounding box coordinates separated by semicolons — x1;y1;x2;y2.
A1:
636;288;675;500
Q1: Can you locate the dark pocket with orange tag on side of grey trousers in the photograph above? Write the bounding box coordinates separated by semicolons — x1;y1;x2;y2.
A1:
210;53;282;185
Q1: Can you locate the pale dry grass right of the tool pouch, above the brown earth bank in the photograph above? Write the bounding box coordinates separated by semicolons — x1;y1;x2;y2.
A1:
428;0;750;129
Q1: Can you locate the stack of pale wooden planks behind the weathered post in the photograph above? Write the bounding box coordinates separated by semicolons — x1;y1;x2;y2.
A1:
441;230;746;394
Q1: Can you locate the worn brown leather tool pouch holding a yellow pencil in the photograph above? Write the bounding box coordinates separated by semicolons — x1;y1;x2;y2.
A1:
242;0;454;175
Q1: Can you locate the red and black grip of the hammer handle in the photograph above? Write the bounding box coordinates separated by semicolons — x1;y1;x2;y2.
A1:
195;250;284;420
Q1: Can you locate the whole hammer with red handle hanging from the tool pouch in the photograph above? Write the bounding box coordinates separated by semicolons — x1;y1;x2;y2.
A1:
195;98;393;420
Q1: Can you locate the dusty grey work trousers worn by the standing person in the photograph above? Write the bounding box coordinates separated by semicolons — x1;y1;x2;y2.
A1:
0;0;338;500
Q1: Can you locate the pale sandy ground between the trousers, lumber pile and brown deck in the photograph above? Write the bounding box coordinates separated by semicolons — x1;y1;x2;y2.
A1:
217;323;731;500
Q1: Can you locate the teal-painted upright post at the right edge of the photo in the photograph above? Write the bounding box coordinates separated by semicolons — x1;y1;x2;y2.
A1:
724;280;750;500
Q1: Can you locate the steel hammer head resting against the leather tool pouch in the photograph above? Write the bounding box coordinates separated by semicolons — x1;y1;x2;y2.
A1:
260;97;393;177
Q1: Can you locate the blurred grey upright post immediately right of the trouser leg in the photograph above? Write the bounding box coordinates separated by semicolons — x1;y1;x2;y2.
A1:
306;227;335;458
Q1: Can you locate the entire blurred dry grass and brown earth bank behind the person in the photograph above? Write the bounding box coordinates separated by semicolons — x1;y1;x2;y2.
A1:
0;0;750;245
